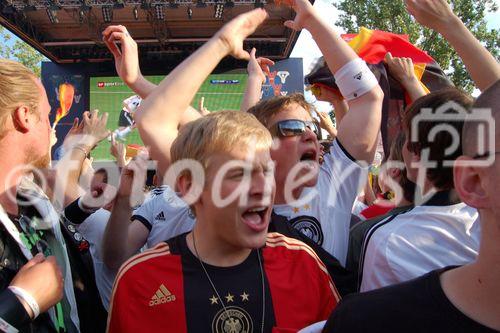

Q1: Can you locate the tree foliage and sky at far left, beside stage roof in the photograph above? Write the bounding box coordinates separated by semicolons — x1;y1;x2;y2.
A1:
0;26;47;76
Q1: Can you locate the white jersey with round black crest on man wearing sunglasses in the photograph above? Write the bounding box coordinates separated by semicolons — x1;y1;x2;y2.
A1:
274;140;368;266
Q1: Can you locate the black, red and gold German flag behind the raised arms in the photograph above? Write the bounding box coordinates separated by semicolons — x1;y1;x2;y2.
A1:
305;28;453;152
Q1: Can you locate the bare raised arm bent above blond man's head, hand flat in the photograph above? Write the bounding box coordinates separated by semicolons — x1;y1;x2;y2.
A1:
132;9;267;175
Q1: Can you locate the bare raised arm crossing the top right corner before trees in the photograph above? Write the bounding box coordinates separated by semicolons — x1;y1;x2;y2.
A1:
405;0;500;91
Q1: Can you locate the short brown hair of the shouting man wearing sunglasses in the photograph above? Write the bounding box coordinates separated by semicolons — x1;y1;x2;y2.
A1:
248;93;314;128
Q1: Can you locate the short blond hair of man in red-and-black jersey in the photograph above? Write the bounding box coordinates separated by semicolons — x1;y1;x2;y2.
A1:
170;111;272;170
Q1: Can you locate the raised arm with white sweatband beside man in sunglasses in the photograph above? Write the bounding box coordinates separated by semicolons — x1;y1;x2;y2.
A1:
285;0;383;163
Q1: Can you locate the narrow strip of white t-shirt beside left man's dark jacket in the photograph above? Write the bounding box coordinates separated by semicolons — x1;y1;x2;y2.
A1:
76;208;116;310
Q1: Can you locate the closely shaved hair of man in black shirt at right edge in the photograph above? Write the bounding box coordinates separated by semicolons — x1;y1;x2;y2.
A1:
462;80;500;157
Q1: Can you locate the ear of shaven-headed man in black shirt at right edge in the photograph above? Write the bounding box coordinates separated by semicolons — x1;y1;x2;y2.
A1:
453;156;489;209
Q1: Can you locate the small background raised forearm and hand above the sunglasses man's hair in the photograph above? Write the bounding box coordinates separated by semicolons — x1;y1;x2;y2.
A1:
240;48;274;112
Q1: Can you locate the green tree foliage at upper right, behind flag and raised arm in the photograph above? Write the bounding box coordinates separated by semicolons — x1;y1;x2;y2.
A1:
334;0;500;93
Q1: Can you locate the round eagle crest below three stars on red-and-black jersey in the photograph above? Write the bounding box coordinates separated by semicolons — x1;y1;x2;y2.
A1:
212;306;253;333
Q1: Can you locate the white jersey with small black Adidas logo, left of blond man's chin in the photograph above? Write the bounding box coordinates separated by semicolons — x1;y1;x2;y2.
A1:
131;185;195;248
